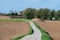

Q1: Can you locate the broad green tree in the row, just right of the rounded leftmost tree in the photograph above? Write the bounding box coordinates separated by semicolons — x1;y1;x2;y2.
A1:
37;8;50;20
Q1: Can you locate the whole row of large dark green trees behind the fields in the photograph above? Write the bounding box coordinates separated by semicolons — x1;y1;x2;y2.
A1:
23;8;60;20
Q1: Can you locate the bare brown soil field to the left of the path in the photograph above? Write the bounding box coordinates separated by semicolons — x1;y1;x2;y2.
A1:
0;22;30;40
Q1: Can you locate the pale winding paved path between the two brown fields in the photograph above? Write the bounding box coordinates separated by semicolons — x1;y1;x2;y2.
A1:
19;21;42;40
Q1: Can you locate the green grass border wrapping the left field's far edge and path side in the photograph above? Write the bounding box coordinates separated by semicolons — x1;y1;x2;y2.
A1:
0;19;33;40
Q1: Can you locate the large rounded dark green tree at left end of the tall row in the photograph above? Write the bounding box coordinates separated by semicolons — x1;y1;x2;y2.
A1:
23;8;35;19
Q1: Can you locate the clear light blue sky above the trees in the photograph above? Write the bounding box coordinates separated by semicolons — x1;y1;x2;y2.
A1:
0;0;60;12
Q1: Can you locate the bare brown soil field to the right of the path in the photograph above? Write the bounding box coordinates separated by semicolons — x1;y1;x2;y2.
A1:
35;19;60;40
